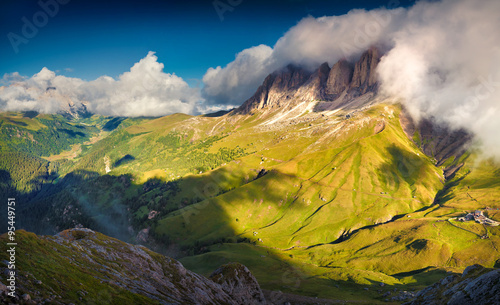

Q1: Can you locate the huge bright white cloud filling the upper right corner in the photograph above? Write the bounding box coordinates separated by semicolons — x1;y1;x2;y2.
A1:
378;0;500;156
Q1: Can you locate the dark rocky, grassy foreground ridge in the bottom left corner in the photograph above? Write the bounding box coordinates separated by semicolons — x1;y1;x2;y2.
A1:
0;229;265;304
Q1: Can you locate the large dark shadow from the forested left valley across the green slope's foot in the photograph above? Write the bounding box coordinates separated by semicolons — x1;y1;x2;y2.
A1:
0;164;456;299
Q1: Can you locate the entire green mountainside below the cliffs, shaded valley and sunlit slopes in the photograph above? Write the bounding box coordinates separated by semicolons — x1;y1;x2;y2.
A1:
1;103;500;302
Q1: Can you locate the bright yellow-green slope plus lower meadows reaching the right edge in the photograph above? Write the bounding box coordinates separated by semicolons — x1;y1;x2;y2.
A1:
172;103;500;297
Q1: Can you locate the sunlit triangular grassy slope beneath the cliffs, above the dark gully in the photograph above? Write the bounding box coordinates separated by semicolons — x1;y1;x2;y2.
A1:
157;104;442;248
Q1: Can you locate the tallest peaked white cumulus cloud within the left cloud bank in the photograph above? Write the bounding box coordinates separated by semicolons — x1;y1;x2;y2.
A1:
80;52;201;116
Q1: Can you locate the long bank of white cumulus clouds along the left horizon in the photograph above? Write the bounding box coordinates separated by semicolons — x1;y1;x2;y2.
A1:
0;52;202;116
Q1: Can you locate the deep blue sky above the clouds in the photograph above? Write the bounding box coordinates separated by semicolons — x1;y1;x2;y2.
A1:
0;0;412;86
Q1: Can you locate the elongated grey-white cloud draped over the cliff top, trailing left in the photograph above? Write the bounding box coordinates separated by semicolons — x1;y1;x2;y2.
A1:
203;9;406;105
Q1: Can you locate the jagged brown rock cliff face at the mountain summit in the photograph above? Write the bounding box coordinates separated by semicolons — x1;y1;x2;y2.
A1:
236;48;381;114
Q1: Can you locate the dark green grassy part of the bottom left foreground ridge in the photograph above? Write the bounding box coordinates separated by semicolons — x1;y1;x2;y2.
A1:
0;231;158;304
